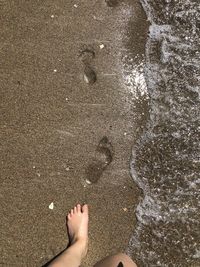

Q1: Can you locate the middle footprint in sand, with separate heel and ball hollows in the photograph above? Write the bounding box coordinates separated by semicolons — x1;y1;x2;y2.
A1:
79;48;97;84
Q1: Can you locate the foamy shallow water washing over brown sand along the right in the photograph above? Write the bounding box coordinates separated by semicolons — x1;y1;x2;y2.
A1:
127;0;200;267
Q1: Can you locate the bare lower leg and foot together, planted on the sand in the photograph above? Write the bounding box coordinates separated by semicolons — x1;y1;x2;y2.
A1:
49;204;88;267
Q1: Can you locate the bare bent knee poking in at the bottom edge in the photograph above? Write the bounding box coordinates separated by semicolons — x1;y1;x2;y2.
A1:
94;253;137;267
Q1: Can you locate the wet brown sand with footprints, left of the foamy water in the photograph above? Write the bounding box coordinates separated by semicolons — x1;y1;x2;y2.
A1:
0;0;148;266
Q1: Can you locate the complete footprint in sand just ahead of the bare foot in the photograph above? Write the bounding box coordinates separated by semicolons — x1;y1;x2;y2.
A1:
85;136;113;184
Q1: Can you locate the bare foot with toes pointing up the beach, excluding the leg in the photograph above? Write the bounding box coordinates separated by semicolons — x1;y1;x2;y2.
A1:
67;204;88;259
